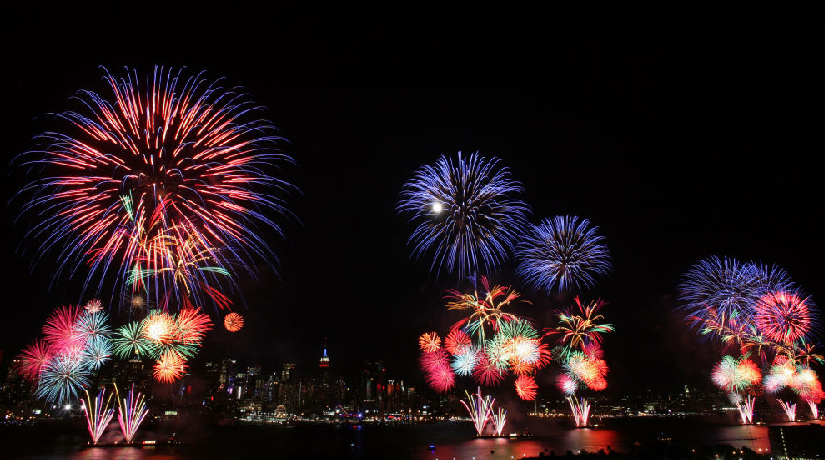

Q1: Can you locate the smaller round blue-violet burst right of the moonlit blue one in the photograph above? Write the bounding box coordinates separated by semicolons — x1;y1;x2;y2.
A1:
516;216;610;294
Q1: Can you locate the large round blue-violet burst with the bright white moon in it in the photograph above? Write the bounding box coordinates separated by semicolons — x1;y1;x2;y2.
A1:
397;152;529;278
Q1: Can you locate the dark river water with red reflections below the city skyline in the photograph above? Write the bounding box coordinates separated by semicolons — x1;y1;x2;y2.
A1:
0;419;770;460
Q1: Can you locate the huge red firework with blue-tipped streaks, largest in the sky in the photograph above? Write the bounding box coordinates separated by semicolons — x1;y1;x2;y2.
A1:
19;67;292;310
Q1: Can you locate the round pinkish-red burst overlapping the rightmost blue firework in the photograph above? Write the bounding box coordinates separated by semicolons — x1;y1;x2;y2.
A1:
754;291;814;344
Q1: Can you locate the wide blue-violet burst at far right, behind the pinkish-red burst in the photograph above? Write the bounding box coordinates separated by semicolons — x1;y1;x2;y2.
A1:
679;256;795;335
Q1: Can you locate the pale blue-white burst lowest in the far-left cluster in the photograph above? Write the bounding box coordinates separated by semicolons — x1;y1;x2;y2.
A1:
34;352;90;404
